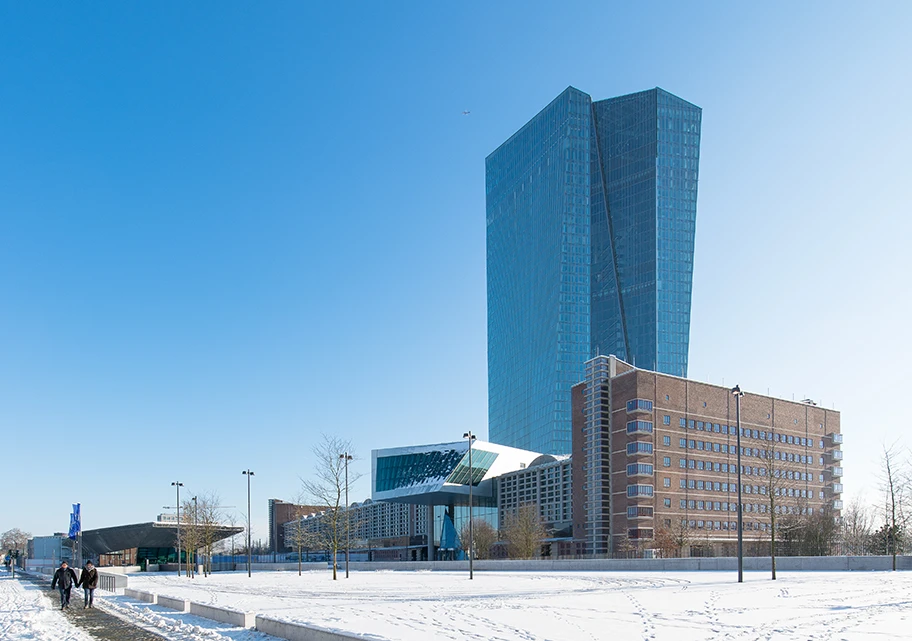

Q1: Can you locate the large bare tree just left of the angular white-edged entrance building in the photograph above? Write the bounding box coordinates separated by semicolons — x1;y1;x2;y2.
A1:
301;434;360;581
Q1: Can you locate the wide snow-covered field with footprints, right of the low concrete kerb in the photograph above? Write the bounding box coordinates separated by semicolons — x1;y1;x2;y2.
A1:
130;571;912;641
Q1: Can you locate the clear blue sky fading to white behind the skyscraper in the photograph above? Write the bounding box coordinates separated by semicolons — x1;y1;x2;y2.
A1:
0;0;912;538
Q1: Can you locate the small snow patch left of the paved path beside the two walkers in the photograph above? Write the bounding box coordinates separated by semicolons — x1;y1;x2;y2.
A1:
0;572;92;641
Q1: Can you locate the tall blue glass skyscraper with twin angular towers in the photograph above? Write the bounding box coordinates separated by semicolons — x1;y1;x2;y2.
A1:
486;87;702;454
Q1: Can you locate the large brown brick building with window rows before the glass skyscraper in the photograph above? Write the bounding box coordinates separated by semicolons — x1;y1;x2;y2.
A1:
572;356;842;554
